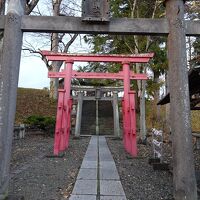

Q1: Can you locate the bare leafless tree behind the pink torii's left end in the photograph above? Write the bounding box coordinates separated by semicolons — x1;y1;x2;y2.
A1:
23;0;81;99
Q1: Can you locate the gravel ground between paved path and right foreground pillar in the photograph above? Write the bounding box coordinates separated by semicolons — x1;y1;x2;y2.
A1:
107;138;172;200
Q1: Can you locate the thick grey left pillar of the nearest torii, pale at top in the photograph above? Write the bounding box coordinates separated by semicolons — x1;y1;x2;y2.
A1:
0;0;25;199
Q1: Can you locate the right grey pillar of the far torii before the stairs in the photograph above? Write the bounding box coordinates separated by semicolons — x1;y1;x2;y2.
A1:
113;91;120;137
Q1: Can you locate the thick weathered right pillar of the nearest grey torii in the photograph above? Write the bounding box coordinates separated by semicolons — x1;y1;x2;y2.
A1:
166;0;197;200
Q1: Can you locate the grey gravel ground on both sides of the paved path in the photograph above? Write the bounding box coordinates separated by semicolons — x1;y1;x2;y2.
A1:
9;134;200;200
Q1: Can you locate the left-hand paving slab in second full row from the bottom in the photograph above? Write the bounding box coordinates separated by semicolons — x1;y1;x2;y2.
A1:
77;168;97;180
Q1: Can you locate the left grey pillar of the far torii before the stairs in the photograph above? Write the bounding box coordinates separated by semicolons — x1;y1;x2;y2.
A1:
75;92;83;138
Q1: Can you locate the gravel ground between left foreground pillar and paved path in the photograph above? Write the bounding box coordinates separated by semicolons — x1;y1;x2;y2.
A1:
9;134;89;200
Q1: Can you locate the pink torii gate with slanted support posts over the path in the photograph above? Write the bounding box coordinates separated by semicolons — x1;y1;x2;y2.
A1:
41;51;154;157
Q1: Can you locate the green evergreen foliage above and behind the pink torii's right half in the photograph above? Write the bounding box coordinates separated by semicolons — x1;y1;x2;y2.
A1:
84;0;167;99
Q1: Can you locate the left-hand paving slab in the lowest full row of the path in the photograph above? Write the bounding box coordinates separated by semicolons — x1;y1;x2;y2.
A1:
72;180;97;195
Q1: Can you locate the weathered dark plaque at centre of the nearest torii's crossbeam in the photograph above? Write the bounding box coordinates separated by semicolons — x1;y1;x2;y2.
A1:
82;0;109;22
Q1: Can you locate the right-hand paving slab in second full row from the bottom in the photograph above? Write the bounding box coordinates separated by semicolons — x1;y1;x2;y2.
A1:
99;168;120;180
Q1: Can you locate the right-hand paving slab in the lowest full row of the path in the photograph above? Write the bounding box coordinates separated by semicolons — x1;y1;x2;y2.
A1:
100;180;125;196
